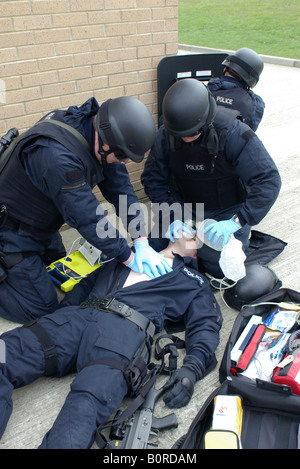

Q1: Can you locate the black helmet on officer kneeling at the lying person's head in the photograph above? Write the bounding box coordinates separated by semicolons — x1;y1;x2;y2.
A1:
162;78;217;137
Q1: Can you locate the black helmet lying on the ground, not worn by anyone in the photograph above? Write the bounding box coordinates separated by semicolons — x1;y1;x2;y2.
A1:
224;264;281;310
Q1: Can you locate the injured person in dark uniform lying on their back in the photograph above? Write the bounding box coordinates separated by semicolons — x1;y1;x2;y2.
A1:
0;229;222;449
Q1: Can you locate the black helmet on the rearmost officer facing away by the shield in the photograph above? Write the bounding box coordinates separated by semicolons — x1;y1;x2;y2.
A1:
222;47;264;88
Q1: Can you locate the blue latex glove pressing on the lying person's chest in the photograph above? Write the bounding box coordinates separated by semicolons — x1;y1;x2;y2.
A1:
127;239;173;278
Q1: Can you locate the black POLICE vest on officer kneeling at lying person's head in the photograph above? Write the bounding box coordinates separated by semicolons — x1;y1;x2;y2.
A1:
168;108;245;211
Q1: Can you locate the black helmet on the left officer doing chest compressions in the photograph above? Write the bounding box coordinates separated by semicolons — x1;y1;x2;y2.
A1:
97;96;156;163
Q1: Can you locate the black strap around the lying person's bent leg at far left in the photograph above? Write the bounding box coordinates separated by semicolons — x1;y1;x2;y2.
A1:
23;319;57;376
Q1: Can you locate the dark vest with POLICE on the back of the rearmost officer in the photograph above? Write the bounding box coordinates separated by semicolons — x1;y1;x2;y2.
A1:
211;87;253;128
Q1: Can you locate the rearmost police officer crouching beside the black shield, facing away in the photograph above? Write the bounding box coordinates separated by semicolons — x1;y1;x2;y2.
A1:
207;47;265;131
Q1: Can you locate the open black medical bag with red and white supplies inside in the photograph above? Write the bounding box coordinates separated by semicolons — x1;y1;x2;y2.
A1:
173;288;300;449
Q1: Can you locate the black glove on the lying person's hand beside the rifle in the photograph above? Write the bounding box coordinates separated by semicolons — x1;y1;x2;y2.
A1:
164;355;204;409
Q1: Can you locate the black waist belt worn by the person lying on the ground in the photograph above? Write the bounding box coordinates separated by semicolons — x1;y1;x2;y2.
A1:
80;297;155;338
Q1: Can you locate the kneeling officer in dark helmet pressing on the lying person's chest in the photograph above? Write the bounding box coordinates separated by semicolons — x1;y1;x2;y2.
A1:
0;97;171;322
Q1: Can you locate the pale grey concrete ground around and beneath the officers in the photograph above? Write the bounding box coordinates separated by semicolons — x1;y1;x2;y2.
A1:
0;50;300;449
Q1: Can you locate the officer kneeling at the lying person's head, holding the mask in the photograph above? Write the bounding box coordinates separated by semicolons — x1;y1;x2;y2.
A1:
142;78;281;278
